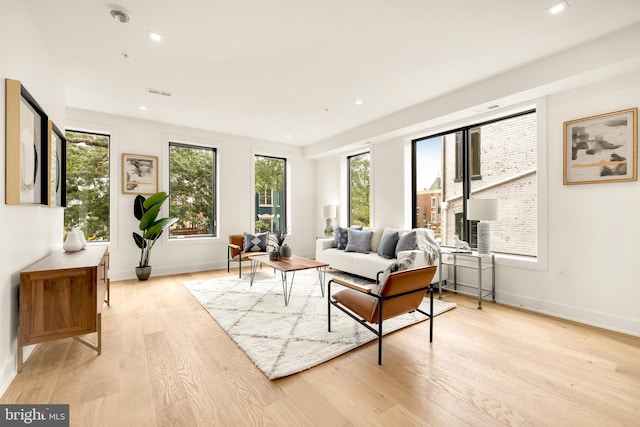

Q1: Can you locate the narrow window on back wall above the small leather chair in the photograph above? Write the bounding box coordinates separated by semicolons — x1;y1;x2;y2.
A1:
254;155;287;233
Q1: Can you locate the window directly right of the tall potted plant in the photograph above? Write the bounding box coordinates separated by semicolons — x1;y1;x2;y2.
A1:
169;142;218;238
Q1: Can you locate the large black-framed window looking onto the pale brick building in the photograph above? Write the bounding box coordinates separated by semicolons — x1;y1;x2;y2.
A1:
413;111;538;256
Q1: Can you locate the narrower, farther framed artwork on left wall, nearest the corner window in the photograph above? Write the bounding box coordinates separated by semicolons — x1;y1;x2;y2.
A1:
49;120;67;207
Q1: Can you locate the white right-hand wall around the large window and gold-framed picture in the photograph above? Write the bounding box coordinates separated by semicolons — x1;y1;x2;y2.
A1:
317;71;640;336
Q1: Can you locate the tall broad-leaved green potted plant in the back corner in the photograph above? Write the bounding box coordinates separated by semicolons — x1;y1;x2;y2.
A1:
133;191;178;280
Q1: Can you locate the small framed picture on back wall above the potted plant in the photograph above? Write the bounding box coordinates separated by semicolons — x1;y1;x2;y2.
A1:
122;153;158;194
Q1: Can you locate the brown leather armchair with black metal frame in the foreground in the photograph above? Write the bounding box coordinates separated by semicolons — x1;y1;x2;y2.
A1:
327;266;436;365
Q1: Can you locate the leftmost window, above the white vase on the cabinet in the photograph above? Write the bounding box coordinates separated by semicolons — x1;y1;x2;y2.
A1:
64;130;110;242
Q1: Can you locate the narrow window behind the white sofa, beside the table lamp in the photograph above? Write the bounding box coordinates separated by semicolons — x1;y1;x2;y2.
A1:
347;153;371;226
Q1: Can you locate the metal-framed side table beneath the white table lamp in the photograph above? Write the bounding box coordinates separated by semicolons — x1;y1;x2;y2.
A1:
438;250;496;310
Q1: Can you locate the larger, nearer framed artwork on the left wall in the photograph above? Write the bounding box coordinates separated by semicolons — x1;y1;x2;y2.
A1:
5;79;49;205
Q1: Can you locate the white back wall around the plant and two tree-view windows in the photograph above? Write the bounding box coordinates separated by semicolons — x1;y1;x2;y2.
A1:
66;109;322;280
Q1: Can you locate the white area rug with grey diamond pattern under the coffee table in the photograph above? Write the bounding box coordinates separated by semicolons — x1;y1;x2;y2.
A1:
184;268;456;380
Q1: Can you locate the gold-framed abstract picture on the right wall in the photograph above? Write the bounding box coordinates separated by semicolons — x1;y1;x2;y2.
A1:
564;108;638;185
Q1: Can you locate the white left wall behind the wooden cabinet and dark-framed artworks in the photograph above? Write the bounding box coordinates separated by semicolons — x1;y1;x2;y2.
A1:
0;0;65;394
